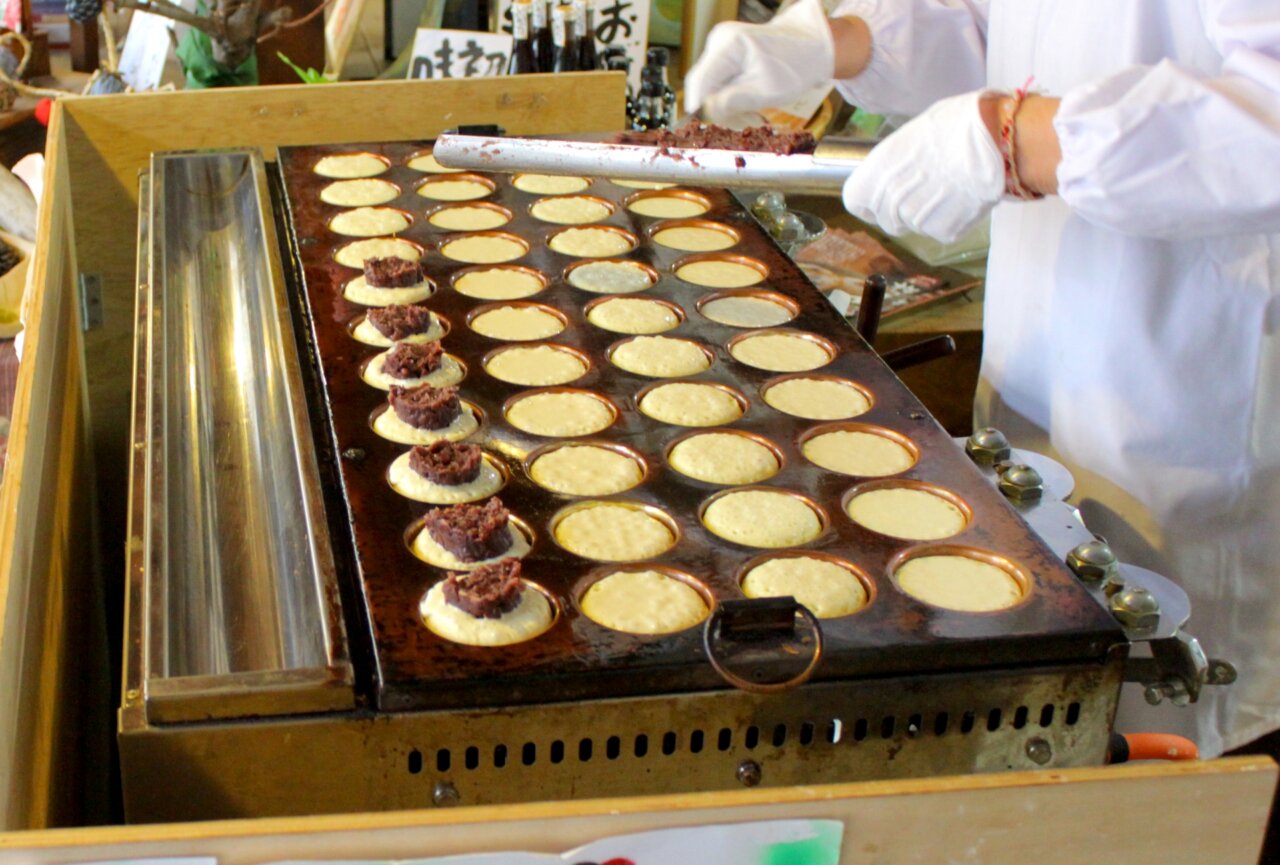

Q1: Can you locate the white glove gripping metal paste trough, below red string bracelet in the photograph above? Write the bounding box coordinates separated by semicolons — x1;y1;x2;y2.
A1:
845;91;1005;243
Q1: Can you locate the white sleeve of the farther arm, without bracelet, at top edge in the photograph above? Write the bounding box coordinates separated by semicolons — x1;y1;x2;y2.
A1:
832;0;989;114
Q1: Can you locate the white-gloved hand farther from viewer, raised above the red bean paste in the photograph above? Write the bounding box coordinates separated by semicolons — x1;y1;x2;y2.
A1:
685;0;836;122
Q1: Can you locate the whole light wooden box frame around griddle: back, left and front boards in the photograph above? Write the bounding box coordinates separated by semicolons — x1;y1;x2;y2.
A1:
0;73;1276;865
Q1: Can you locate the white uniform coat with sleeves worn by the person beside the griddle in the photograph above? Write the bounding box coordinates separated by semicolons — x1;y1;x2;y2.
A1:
840;0;1280;756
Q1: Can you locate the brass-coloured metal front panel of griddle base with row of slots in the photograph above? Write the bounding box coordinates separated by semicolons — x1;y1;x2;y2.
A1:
120;649;1124;821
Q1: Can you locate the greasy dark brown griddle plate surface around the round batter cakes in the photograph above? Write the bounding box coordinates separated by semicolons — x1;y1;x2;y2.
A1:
279;143;1119;710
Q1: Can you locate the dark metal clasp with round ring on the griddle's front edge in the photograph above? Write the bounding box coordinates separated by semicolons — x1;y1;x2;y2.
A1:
703;598;822;694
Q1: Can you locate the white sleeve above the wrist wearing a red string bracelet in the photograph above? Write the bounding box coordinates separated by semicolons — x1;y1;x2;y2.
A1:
1053;0;1280;239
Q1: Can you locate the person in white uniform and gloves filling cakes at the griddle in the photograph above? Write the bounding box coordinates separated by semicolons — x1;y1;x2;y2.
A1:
686;0;1280;755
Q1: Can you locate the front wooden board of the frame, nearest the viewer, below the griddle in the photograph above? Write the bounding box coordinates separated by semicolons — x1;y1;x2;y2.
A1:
0;758;1276;865
